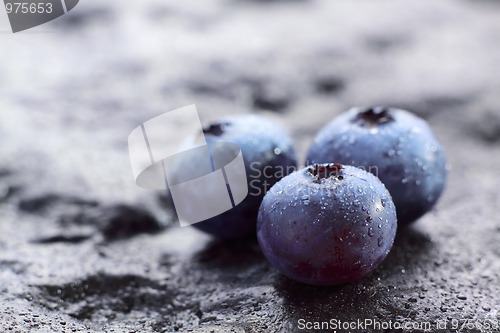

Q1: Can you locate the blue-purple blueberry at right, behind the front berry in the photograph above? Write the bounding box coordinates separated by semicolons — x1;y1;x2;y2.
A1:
307;107;446;225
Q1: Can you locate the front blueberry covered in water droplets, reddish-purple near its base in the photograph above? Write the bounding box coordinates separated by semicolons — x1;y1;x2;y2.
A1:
257;164;397;286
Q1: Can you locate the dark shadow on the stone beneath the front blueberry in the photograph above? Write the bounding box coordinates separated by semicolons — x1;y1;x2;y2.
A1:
274;226;434;322
